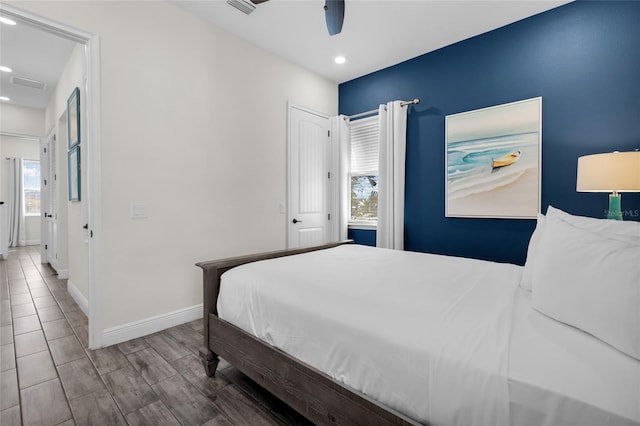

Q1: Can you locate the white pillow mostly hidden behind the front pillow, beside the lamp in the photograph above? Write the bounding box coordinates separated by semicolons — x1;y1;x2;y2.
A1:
520;206;640;291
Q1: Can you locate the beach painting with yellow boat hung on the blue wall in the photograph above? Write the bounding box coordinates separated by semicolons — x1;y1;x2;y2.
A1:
445;97;542;219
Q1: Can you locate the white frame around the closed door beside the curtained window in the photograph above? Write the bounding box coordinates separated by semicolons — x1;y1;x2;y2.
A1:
285;102;338;248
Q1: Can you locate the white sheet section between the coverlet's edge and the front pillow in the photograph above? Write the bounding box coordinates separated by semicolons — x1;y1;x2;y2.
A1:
509;289;640;426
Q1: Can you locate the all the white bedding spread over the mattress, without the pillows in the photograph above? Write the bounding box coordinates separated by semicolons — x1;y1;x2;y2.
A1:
218;245;640;426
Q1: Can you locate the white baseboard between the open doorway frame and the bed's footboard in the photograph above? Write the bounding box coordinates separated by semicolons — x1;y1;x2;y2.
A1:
102;303;202;346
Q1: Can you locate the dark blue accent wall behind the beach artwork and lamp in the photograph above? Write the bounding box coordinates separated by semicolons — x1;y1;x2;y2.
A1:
339;1;640;264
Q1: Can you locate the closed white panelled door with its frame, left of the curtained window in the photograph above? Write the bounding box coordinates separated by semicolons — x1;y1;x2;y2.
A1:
288;106;331;248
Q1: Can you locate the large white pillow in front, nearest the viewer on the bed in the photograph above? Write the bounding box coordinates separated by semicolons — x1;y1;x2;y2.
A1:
532;215;640;360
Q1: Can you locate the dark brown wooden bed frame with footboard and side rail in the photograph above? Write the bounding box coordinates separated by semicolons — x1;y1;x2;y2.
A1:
197;241;420;425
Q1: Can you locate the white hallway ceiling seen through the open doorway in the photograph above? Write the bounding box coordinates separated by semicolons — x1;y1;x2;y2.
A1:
0;15;76;109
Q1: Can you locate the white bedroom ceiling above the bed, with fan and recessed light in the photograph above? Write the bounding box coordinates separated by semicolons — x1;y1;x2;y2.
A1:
171;0;568;83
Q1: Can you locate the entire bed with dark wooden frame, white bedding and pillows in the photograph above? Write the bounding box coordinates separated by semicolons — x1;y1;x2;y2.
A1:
198;206;640;426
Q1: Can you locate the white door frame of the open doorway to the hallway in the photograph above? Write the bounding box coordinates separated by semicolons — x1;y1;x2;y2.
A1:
0;3;102;349
